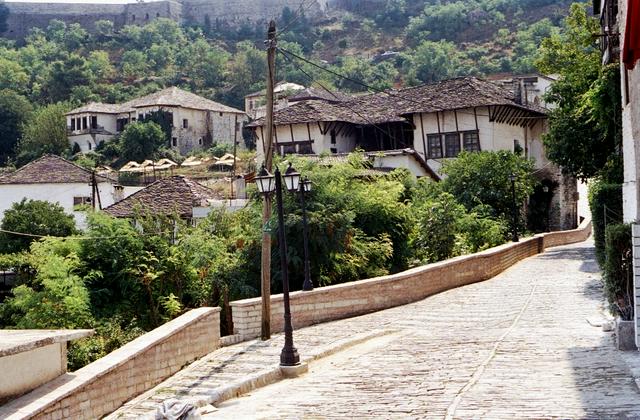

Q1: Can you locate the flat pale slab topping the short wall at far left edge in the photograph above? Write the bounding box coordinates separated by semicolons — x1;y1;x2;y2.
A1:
0;330;95;357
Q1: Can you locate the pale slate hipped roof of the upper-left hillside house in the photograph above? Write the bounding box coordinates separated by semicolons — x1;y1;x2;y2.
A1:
66;86;244;115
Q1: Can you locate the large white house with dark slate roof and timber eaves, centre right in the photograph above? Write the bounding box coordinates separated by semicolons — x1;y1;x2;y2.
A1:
249;77;578;230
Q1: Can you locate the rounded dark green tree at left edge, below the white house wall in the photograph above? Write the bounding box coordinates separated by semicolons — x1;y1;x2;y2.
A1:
0;198;76;254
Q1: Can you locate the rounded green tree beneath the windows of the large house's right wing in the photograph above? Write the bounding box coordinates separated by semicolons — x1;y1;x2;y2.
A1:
442;151;535;223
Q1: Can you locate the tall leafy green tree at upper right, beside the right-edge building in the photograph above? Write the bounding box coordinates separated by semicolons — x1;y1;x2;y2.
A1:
536;3;622;182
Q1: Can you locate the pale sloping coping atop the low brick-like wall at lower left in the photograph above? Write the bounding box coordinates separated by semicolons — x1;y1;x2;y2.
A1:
0;307;220;419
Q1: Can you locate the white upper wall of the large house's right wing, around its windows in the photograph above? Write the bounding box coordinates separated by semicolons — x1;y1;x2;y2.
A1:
413;107;548;171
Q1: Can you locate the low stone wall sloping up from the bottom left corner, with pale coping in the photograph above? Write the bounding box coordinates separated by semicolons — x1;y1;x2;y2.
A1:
0;308;220;419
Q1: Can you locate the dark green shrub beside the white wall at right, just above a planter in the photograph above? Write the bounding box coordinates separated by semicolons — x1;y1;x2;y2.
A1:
603;224;634;321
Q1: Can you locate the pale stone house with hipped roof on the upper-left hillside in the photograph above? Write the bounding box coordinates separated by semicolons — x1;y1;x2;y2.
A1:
66;87;247;154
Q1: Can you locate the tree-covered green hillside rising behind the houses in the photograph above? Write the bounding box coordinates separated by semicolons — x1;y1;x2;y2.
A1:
0;0;580;165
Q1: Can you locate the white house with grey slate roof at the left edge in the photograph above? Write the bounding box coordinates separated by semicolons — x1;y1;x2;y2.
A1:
0;155;139;227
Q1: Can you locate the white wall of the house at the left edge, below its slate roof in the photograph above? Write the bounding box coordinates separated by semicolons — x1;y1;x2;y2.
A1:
0;182;141;229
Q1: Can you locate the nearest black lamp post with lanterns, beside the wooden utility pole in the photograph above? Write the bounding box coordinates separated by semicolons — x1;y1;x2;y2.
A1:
256;165;300;366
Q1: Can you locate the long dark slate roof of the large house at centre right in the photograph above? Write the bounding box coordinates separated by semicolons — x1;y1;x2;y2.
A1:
249;77;546;127
